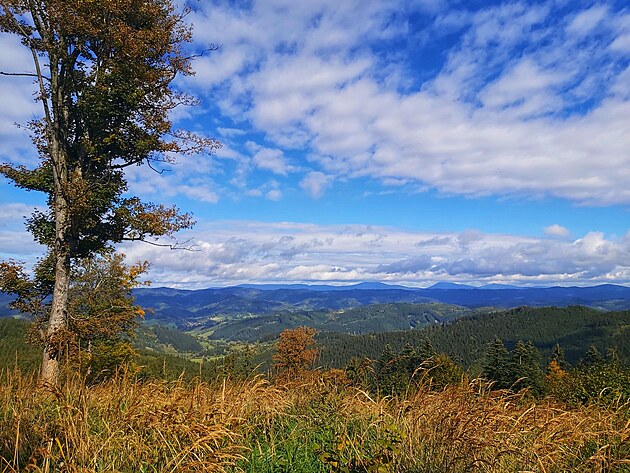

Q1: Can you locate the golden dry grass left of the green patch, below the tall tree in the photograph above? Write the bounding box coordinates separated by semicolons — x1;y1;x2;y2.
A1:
0;374;283;472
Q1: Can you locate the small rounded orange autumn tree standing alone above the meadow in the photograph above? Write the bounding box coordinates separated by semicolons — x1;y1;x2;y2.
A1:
272;327;318;376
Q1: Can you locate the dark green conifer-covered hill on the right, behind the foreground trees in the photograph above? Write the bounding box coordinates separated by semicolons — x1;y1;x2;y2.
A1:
317;307;630;367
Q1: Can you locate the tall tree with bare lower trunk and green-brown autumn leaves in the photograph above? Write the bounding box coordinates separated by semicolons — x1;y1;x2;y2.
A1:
0;0;219;383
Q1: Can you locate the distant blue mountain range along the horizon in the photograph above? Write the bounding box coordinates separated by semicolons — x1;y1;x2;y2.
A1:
127;284;630;328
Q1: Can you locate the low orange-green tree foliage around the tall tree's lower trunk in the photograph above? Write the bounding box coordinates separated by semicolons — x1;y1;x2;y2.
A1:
0;252;148;381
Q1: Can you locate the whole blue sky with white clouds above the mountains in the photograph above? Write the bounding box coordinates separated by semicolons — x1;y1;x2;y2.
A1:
0;0;630;289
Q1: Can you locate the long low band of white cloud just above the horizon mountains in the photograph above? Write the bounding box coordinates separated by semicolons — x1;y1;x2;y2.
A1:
113;221;630;287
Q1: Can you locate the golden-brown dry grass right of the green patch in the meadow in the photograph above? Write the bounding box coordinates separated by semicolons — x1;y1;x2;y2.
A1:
396;383;630;472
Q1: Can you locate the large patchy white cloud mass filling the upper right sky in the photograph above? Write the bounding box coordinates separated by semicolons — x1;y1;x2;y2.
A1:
177;0;630;205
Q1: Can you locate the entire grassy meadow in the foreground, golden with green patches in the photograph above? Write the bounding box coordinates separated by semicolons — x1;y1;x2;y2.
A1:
0;371;630;473
